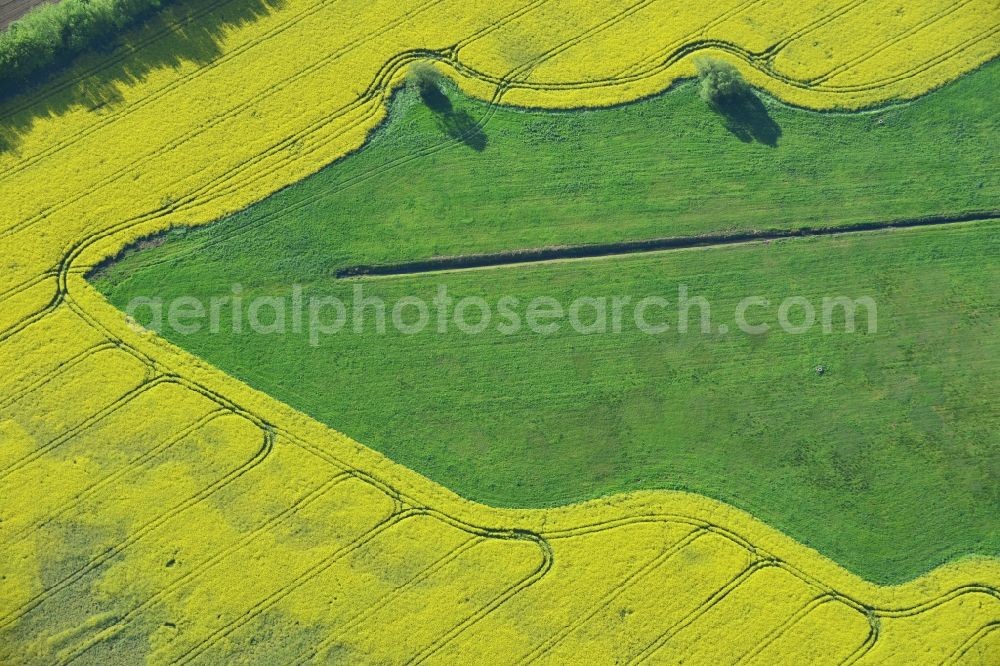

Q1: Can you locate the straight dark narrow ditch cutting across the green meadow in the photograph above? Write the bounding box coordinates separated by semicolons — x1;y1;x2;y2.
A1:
334;210;1000;279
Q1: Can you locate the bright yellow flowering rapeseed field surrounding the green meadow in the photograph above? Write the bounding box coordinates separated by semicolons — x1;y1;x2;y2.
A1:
0;0;1000;664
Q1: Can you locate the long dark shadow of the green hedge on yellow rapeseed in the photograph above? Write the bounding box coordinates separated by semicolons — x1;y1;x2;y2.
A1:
0;0;286;153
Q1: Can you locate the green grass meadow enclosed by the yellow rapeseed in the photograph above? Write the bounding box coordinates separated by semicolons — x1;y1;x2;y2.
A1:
94;65;1000;582
